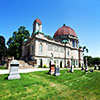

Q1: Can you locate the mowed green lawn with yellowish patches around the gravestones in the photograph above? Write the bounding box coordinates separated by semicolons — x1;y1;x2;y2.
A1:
0;70;100;100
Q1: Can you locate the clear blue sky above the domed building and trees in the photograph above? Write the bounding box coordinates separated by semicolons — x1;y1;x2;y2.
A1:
0;0;100;57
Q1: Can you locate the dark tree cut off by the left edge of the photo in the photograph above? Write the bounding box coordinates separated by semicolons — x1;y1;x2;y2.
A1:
0;36;7;60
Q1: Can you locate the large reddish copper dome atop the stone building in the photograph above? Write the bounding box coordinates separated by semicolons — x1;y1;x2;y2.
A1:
53;24;77;37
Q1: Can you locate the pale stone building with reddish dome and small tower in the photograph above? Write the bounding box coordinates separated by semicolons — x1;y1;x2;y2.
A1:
22;18;83;67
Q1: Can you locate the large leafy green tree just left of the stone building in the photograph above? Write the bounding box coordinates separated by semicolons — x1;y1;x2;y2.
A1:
7;26;30;59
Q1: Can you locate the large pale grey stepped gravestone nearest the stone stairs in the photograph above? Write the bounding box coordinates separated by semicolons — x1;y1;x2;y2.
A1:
8;60;20;80
